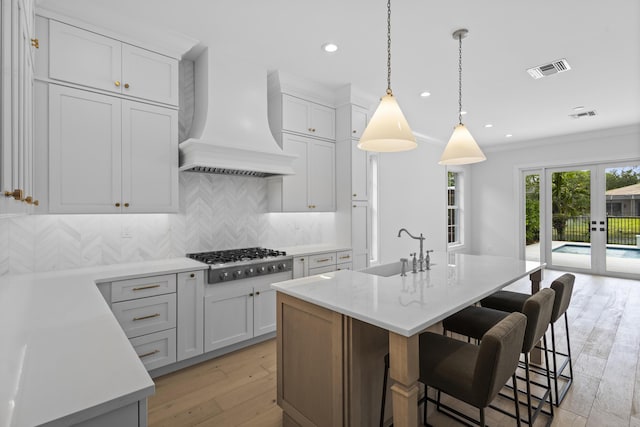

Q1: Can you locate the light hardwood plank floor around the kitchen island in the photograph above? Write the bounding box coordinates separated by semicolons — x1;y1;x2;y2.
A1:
149;270;640;427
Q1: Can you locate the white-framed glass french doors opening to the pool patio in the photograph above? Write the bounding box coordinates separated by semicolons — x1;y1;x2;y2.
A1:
522;161;640;278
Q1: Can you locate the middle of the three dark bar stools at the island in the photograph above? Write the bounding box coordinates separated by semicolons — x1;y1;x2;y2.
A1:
442;288;555;425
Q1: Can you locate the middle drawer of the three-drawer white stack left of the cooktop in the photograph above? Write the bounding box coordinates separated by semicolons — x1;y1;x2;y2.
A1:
111;294;176;338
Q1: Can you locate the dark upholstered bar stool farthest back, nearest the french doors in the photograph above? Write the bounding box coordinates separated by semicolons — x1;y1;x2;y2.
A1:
481;273;576;406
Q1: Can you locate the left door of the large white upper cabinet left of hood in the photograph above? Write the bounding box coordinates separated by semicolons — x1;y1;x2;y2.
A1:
49;84;122;213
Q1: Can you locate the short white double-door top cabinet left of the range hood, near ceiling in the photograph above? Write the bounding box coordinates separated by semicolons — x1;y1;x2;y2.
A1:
49;20;178;105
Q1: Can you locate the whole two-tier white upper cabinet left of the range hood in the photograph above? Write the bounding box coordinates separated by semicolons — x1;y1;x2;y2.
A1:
35;16;178;213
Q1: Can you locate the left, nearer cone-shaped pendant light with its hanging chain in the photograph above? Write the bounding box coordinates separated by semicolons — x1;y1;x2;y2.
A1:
358;0;418;152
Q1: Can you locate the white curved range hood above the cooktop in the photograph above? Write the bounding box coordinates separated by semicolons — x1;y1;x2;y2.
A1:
180;48;297;177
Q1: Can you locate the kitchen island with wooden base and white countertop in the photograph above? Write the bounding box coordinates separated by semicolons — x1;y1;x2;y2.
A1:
272;253;544;427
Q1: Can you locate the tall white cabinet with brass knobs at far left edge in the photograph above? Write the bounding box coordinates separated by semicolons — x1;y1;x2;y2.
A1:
0;0;39;215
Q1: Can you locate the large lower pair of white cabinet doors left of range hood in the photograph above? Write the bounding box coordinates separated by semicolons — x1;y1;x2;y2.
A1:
49;84;178;213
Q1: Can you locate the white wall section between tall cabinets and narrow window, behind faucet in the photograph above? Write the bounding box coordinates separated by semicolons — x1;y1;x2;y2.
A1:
379;140;447;263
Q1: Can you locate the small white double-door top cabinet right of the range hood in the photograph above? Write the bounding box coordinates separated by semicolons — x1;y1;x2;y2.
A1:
282;94;336;140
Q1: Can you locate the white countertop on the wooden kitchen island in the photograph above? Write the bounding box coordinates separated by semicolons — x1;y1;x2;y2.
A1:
272;253;543;337
